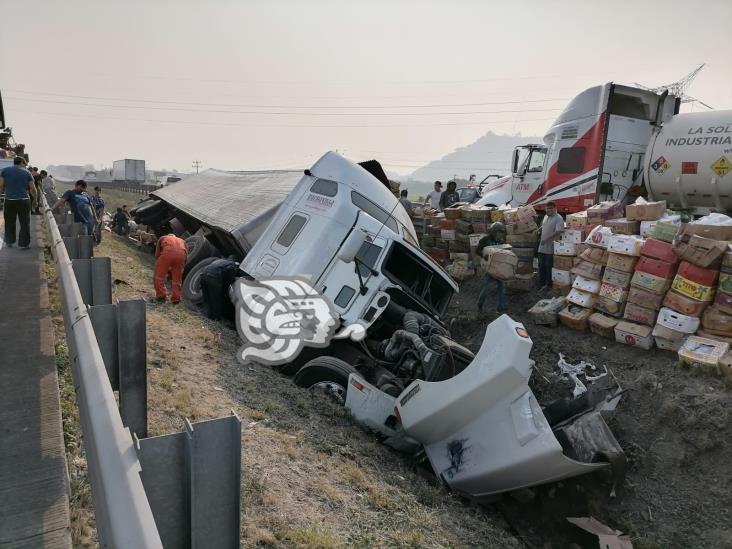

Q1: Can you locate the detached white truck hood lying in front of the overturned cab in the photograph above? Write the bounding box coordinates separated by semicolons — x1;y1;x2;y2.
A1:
397;315;619;500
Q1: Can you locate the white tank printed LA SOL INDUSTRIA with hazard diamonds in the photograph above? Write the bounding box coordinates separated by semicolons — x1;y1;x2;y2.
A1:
644;110;732;215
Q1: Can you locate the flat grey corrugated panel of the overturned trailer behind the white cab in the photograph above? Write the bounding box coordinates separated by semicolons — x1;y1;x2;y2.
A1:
152;169;303;253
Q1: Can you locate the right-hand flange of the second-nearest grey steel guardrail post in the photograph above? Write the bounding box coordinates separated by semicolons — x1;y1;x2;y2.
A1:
117;299;147;438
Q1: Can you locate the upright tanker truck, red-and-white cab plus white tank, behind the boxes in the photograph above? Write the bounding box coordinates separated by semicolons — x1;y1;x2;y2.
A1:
478;83;732;215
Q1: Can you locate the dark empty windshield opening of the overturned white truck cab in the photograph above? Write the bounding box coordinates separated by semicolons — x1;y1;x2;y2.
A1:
382;242;453;314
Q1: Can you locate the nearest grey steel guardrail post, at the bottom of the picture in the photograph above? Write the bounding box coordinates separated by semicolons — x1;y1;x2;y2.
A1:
137;412;241;549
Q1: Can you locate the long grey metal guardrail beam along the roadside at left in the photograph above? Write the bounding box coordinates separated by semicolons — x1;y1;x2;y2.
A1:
43;199;163;549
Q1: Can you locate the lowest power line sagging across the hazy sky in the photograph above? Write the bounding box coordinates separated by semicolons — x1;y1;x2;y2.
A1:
13;109;554;128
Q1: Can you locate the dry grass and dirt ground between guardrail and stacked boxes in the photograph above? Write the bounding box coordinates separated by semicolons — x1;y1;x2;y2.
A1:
58;216;732;549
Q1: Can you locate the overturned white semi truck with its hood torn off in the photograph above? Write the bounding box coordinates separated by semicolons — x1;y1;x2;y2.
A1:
132;152;624;499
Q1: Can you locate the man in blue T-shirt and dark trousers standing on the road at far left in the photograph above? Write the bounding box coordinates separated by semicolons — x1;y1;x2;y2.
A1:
0;156;38;250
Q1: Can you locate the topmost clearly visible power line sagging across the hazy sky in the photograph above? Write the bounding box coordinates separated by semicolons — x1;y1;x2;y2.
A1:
5;89;570;112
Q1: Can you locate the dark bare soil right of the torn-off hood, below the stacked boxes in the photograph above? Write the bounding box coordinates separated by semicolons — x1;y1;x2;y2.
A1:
452;280;732;549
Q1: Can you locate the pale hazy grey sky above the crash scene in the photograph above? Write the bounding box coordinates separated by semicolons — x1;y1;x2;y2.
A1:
0;0;732;173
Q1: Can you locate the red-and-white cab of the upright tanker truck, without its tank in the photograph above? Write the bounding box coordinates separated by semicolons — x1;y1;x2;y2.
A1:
478;82;678;213
